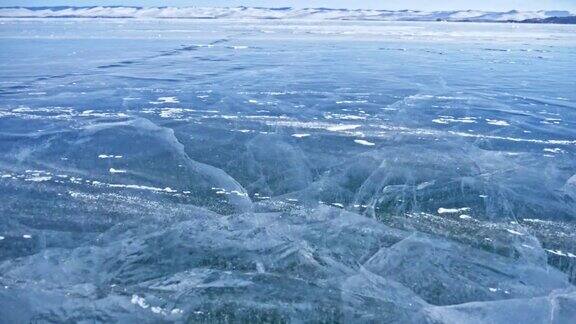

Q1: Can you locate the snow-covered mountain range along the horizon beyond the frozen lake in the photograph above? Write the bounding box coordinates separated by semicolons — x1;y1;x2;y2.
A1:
0;6;576;24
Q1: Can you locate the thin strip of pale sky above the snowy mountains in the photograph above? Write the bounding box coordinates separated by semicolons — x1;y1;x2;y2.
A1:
0;0;576;12
